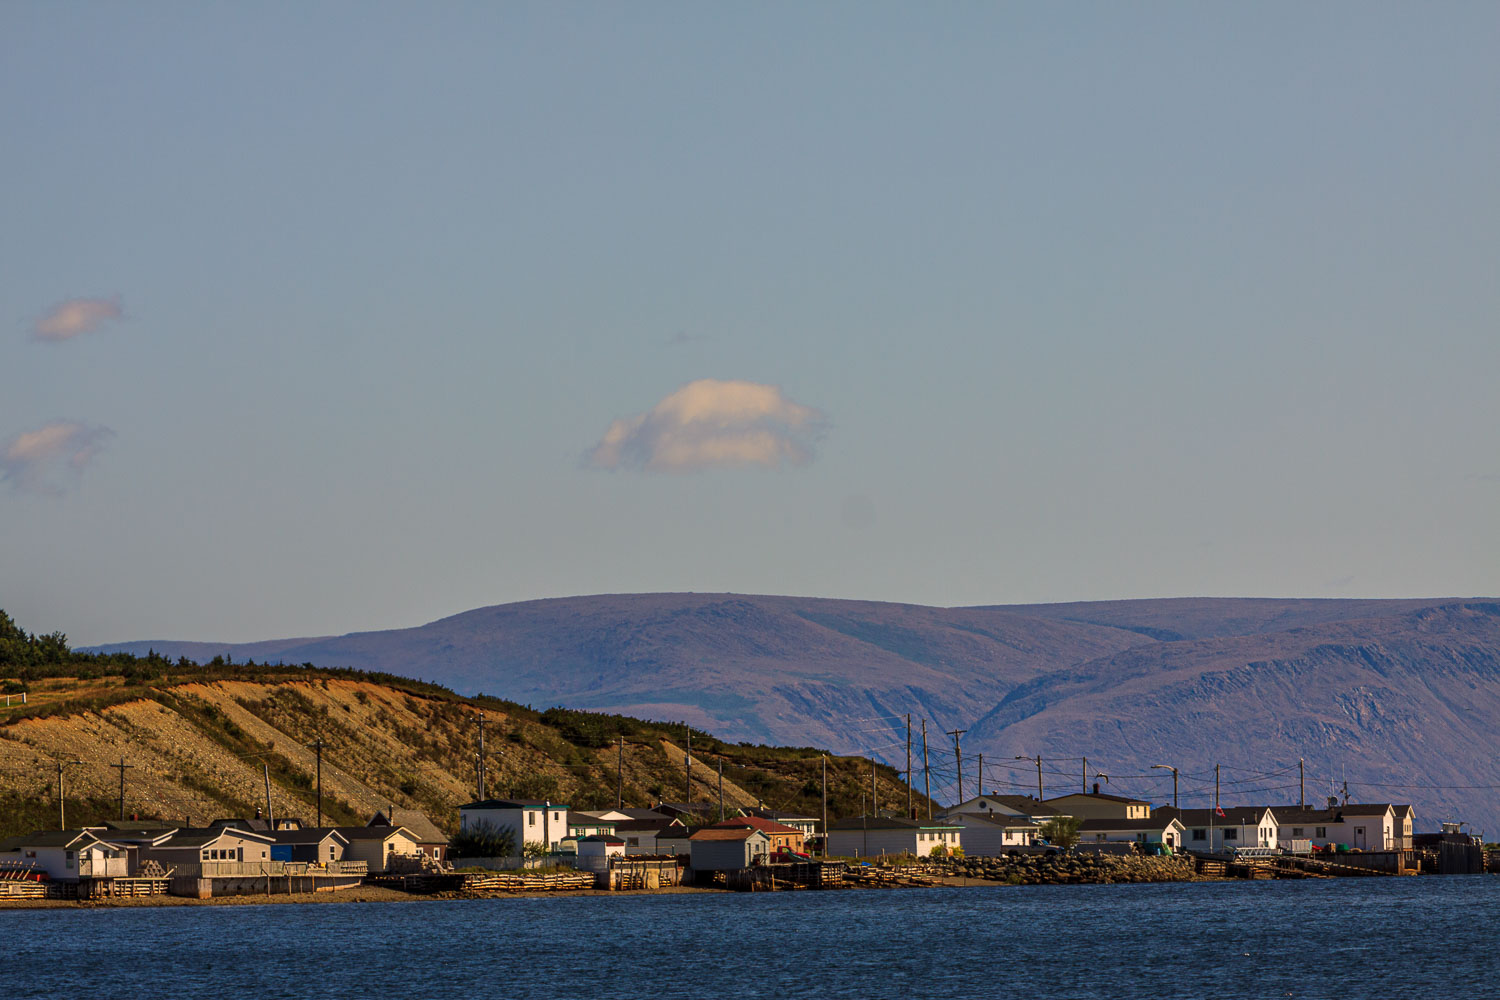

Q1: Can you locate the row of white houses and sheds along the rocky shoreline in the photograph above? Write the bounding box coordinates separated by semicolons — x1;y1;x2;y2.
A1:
0;786;1488;903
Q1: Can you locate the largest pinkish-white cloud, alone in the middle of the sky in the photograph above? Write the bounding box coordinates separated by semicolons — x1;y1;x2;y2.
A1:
587;378;827;472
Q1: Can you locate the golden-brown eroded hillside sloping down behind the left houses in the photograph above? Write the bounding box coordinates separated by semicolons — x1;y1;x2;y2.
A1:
0;619;906;837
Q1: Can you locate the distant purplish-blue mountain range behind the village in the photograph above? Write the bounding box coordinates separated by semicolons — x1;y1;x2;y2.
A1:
90;594;1500;834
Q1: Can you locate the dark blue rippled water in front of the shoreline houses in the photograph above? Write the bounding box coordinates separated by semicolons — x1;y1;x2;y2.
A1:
0;876;1500;1000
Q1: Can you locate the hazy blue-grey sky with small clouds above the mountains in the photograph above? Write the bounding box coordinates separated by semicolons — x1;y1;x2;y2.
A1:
0;0;1500;643
